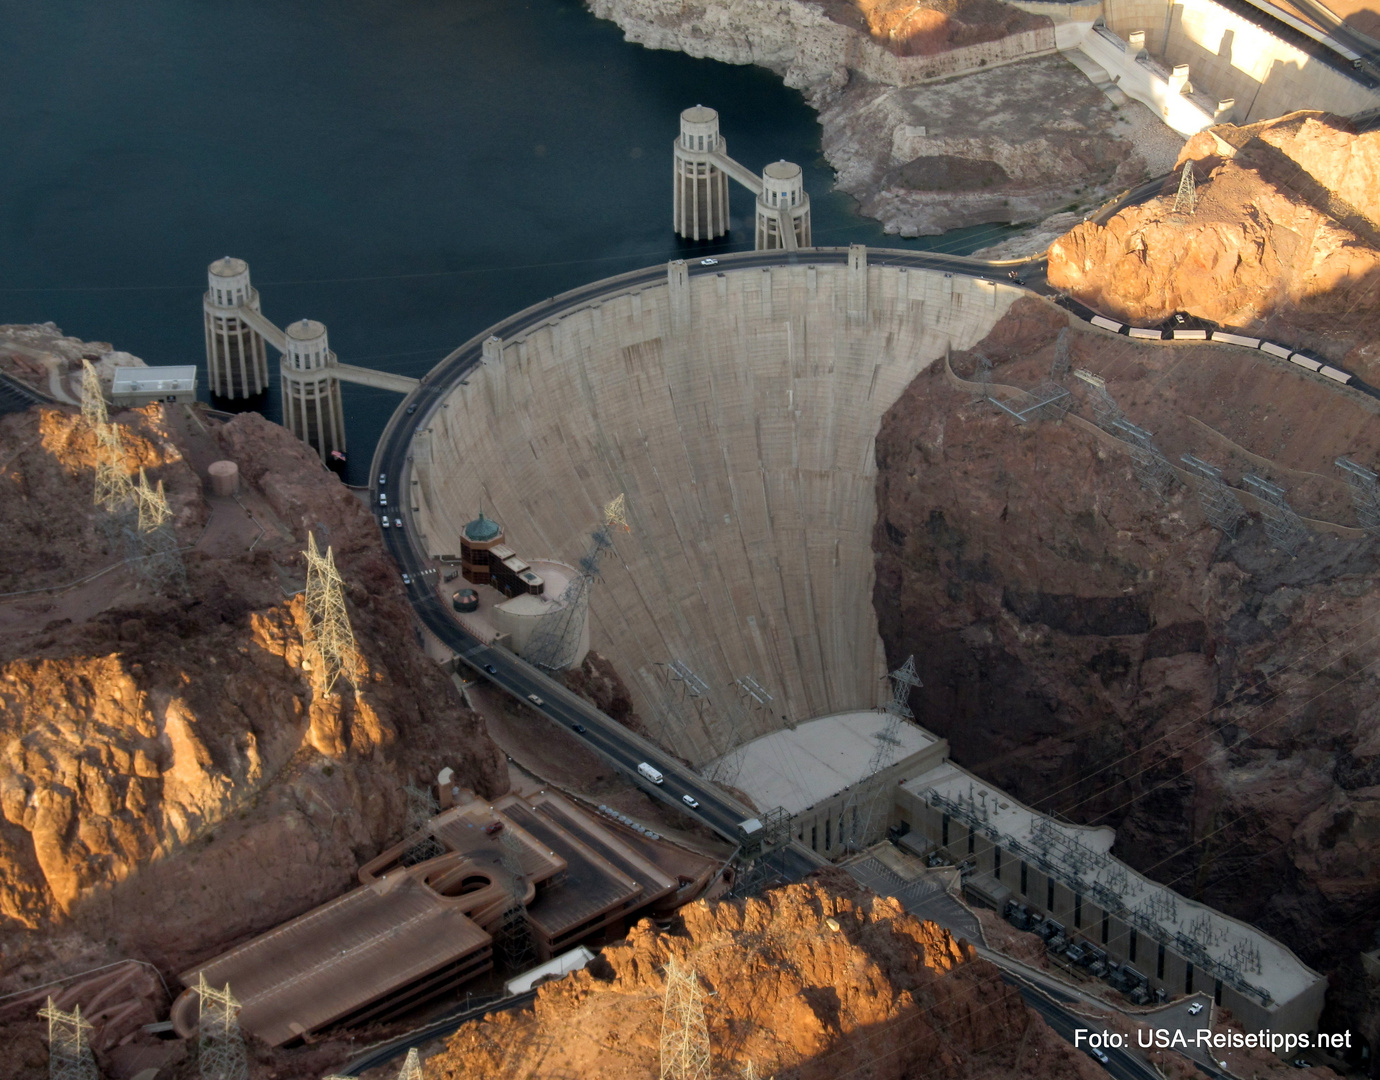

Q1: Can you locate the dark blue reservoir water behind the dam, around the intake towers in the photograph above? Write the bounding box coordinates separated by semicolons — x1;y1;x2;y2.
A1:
0;0;1015;479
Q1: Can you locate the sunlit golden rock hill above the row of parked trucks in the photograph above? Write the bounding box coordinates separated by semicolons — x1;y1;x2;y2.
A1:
1049;113;1380;377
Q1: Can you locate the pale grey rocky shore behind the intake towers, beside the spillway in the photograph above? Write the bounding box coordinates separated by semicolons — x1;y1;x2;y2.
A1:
587;0;1183;236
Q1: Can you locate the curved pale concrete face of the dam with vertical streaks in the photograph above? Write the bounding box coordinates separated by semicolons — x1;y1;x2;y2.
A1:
413;259;1017;764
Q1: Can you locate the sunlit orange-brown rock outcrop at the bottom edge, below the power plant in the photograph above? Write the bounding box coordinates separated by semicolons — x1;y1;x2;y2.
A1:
426;876;1097;1080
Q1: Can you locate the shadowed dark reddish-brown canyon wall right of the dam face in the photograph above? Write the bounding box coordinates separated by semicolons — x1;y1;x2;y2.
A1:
874;301;1380;1053
